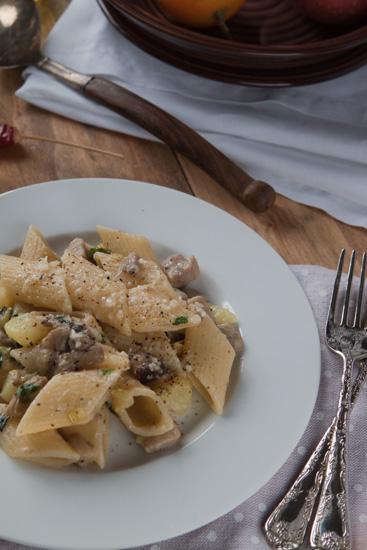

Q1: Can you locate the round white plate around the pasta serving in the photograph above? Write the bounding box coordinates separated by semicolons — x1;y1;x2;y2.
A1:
0;179;320;550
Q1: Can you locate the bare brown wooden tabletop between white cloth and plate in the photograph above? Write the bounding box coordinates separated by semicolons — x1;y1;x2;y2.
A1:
0;0;367;268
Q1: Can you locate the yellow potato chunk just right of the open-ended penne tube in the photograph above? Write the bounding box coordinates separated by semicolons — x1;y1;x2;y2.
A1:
150;376;192;416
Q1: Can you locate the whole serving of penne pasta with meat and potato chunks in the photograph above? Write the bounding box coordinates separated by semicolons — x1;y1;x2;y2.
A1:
0;226;244;469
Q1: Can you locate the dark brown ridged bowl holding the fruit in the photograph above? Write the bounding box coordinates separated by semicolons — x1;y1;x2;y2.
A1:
100;0;367;86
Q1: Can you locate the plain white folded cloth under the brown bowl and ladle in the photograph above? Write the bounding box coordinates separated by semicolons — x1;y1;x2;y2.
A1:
18;0;367;226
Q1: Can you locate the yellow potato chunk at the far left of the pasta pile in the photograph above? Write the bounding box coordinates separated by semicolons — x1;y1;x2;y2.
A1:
4;313;51;347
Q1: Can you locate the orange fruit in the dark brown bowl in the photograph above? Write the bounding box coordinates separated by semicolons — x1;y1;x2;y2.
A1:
156;0;245;28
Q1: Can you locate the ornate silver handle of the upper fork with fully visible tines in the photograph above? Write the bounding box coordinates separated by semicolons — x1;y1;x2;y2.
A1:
310;351;353;550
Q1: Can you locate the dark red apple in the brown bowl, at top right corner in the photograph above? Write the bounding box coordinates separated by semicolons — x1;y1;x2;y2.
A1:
298;0;367;25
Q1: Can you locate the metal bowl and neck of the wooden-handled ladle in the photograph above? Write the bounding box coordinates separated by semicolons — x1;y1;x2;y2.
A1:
0;0;92;89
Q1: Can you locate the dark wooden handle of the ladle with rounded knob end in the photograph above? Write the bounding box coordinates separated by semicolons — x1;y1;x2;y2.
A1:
83;77;275;212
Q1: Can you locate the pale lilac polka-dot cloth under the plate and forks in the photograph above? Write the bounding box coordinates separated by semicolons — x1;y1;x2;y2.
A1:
0;266;367;550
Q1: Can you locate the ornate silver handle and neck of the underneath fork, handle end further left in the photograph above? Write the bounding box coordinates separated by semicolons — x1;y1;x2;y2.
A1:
265;361;367;550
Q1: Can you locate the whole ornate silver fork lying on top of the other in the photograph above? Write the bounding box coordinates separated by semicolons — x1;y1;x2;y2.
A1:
310;250;367;550
